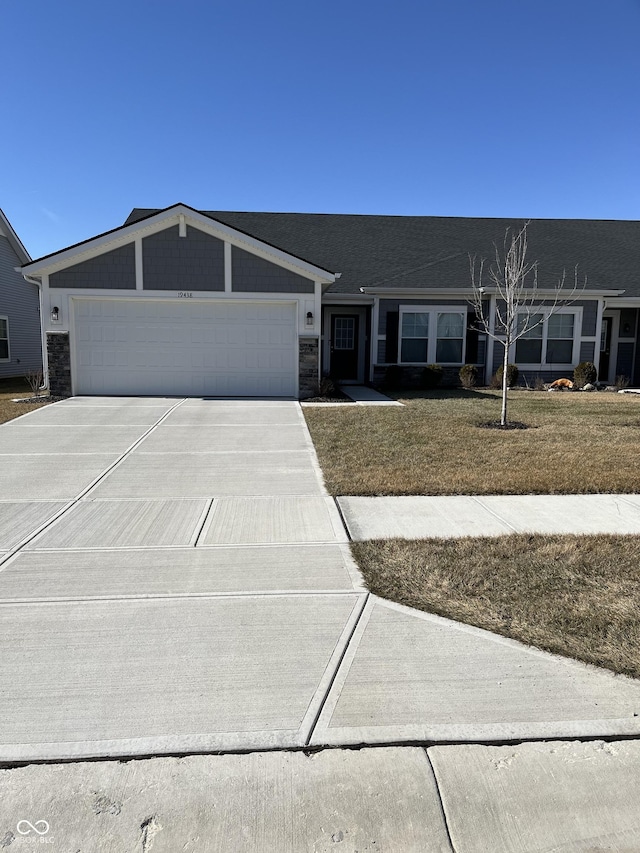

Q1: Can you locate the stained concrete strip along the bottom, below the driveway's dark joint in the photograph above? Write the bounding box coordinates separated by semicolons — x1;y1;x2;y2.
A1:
0;741;640;853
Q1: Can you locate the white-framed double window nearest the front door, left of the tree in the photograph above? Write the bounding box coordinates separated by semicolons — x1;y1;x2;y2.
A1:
398;305;467;364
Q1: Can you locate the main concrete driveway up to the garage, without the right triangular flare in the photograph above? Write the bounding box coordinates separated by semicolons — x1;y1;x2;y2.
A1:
0;397;365;761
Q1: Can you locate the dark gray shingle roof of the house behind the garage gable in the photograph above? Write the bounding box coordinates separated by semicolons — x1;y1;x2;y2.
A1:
125;208;640;296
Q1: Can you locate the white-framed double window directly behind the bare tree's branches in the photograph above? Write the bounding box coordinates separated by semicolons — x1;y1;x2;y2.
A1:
514;309;581;367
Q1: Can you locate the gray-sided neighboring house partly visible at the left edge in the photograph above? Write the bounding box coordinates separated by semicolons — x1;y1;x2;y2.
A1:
0;210;42;379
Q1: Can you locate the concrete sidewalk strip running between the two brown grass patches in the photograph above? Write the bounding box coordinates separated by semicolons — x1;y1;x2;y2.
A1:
337;495;640;541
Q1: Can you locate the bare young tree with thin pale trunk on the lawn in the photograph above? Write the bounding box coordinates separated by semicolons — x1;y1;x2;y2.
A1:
469;221;586;427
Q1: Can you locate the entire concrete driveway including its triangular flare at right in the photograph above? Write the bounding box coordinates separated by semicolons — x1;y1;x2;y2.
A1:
0;398;640;762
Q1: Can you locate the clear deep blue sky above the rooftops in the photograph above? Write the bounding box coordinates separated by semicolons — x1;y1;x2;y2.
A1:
0;0;640;258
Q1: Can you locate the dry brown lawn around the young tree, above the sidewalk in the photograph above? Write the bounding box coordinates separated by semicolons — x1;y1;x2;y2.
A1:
304;390;640;495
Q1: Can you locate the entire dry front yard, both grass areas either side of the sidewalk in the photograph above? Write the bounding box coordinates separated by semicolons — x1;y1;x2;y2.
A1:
305;390;640;678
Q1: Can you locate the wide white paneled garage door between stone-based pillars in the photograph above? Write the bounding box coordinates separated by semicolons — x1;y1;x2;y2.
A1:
74;299;297;397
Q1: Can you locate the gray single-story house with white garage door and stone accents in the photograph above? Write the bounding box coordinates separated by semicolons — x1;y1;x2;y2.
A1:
17;204;640;397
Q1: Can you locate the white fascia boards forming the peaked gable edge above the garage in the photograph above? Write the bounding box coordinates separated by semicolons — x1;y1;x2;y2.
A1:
21;204;336;284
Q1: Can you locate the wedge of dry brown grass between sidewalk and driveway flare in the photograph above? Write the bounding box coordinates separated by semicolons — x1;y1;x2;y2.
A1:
351;535;640;678
